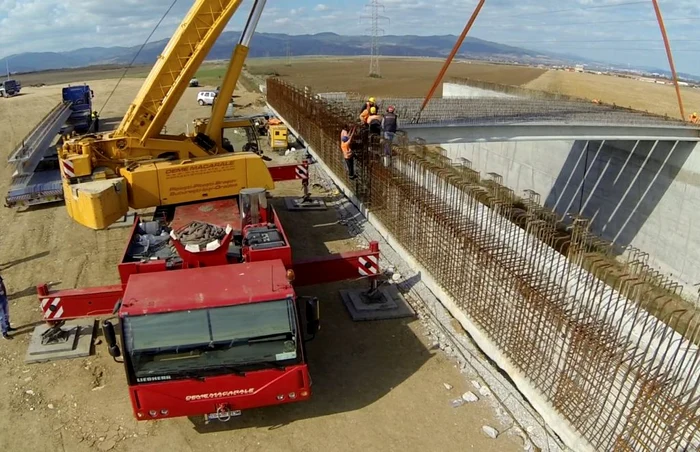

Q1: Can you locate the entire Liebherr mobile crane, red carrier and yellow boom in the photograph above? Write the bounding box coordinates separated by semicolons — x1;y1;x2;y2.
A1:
35;0;380;421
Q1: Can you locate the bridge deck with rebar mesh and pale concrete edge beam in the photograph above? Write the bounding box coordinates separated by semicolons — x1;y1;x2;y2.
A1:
328;95;700;144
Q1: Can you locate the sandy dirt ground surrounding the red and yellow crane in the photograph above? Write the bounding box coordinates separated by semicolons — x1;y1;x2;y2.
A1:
0;79;522;452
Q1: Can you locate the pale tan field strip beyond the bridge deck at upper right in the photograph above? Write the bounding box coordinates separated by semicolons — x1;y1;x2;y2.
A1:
524;71;700;119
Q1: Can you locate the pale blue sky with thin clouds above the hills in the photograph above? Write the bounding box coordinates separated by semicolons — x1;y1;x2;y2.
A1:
0;0;700;75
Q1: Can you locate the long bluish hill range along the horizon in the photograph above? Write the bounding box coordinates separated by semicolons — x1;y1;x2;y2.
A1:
0;31;570;72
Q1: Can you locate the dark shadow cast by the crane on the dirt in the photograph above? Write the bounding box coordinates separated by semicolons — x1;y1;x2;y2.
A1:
190;193;433;433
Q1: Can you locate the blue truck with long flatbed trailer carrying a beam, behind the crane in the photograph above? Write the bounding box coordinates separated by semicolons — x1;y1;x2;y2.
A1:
5;85;97;207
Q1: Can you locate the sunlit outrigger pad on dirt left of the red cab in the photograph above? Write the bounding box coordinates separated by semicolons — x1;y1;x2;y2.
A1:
24;319;95;364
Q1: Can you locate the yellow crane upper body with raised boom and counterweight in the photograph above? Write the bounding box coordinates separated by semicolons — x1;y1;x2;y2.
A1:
59;0;274;229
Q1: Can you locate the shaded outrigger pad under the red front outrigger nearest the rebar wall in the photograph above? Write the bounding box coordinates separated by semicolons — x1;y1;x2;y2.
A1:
340;284;416;322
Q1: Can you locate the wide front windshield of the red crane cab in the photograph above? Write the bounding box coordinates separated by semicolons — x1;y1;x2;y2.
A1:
124;299;297;382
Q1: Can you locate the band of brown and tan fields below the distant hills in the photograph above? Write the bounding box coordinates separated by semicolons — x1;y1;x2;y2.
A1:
10;57;700;117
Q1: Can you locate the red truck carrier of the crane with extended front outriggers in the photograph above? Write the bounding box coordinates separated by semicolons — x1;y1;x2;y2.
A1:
30;188;379;421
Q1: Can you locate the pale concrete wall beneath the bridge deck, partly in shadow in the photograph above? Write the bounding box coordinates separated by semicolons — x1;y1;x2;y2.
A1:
442;140;700;300
